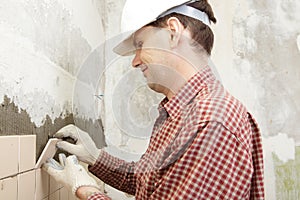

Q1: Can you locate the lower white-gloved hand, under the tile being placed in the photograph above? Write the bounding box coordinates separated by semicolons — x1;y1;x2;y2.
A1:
42;154;100;195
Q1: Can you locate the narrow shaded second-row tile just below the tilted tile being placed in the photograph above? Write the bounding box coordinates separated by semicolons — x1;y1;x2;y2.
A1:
35;169;49;200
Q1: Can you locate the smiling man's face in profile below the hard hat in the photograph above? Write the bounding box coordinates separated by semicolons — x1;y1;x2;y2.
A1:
132;26;183;94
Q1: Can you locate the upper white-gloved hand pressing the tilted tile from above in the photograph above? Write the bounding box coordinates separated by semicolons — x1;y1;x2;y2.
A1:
54;124;100;165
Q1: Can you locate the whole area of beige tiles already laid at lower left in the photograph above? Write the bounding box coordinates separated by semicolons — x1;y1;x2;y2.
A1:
0;135;76;200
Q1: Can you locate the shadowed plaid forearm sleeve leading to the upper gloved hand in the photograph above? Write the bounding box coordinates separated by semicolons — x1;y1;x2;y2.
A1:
89;150;136;195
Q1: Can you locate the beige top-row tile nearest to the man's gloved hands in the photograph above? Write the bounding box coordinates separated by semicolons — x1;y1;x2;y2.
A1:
19;135;36;172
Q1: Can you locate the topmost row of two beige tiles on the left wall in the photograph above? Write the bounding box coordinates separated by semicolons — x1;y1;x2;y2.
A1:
0;135;36;179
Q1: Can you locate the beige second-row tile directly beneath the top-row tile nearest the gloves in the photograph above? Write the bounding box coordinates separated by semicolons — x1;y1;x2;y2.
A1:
17;170;35;200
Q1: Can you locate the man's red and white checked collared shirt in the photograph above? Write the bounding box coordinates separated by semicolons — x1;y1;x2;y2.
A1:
89;67;264;200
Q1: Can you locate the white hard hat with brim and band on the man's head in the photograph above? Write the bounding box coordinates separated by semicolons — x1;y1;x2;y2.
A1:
113;0;210;56
